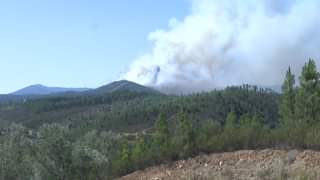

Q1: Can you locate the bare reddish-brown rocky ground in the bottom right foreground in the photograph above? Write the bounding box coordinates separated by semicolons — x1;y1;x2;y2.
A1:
119;150;320;180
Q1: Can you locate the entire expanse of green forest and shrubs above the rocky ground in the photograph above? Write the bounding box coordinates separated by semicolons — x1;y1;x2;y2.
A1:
0;60;320;180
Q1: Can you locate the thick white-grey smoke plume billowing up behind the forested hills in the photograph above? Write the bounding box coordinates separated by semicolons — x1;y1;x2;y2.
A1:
125;0;320;93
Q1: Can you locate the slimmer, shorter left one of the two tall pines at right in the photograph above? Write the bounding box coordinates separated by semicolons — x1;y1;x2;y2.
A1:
280;67;296;126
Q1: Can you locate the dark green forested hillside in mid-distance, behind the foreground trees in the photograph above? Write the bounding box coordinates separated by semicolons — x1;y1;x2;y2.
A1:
0;85;279;131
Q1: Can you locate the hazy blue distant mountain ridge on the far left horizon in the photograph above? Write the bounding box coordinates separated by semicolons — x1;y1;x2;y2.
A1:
10;84;90;96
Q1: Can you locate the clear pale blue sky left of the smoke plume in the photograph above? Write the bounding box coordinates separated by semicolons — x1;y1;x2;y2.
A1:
0;0;190;93
